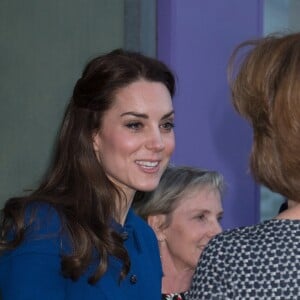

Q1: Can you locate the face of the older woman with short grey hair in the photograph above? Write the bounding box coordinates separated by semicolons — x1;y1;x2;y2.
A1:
160;186;223;270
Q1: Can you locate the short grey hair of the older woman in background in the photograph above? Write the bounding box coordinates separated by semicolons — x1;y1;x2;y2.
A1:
133;166;224;228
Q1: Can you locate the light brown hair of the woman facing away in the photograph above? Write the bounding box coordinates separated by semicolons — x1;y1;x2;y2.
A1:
228;33;300;199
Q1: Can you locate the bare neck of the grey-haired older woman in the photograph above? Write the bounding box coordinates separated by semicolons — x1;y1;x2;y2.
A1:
160;241;194;294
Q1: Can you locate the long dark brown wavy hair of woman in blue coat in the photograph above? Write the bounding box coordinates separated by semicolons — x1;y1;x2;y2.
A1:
0;49;175;283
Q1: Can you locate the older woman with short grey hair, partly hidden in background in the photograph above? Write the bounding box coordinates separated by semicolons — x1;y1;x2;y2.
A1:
133;166;224;300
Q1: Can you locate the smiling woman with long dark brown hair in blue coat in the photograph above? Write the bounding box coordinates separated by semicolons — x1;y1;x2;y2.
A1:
0;50;175;300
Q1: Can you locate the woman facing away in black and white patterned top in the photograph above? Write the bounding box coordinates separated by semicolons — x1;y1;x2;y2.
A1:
189;33;300;300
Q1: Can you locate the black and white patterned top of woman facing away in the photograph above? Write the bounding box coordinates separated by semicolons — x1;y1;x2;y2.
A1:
188;219;300;300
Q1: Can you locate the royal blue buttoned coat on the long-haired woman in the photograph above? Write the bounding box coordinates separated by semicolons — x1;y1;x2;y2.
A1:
0;206;162;300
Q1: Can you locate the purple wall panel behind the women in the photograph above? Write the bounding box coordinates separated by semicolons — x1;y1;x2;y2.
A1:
157;0;262;228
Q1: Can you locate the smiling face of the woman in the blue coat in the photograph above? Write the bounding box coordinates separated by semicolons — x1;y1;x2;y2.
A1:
94;80;175;200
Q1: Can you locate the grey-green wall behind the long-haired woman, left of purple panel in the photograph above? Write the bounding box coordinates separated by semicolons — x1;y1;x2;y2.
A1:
0;0;155;206
